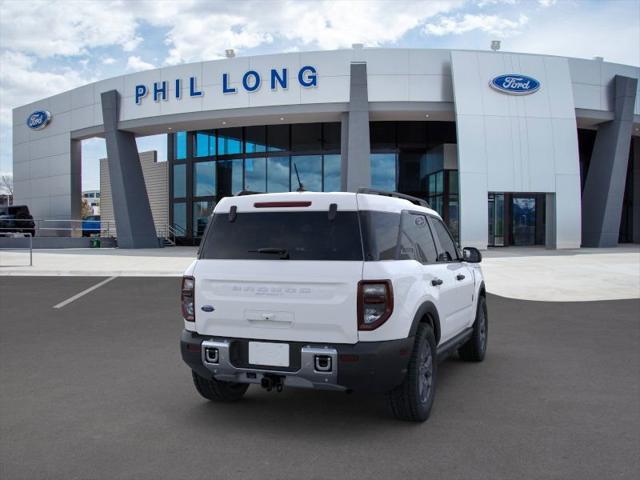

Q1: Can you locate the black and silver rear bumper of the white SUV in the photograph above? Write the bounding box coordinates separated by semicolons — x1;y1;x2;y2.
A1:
180;330;414;392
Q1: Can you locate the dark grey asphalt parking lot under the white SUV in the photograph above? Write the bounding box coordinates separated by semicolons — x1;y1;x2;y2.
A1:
0;277;640;480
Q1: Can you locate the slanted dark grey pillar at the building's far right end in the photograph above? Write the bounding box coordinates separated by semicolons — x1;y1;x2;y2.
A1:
582;75;638;247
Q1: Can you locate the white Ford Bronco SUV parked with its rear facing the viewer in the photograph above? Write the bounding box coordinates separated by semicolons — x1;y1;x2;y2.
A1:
181;190;487;421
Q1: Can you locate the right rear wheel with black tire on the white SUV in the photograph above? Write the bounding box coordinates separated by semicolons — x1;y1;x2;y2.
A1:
387;323;437;422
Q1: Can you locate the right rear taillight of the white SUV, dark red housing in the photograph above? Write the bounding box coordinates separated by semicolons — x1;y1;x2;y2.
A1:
358;280;393;330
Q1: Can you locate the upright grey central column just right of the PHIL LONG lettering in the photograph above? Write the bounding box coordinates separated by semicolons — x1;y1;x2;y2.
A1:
341;63;371;192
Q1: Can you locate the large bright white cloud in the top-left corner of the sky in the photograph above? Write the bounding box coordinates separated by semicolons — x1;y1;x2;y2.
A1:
0;0;141;58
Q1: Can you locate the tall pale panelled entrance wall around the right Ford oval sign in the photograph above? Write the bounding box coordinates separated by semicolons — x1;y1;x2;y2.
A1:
451;52;581;248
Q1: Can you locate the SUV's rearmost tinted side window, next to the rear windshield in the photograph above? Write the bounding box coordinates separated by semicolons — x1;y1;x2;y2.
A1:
360;211;400;262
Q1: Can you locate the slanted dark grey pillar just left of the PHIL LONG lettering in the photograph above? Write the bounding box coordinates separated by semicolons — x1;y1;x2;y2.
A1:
101;90;160;248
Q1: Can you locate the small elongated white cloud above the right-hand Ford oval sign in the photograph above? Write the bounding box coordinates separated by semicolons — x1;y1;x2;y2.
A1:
424;14;529;38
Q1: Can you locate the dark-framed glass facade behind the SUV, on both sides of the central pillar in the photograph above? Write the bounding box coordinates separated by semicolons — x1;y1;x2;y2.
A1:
169;121;459;241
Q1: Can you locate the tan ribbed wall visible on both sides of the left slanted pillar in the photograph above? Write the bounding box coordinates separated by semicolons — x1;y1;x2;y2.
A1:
100;151;169;236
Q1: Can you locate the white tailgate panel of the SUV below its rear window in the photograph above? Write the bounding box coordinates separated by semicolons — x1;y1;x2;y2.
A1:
194;260;362;343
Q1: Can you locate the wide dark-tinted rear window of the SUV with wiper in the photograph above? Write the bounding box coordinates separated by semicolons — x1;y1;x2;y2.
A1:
200;211;362;261
